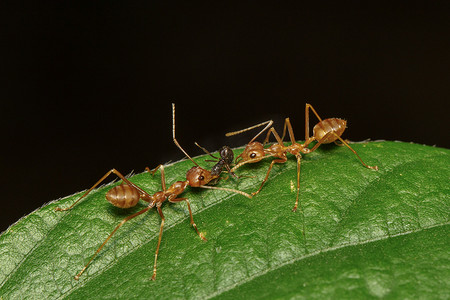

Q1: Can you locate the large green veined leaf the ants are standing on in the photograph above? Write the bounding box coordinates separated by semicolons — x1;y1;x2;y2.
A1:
0;142;450;299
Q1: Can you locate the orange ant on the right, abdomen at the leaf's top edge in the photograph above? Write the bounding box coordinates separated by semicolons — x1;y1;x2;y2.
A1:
226;104;378;212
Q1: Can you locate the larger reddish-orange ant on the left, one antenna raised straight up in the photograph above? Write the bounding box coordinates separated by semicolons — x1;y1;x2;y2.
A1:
55;104;251;280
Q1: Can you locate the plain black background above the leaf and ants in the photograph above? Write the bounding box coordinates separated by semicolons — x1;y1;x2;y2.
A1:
0;1;450;232
